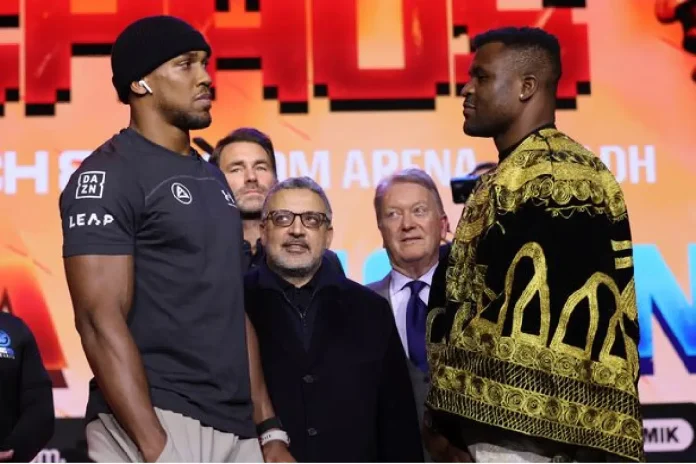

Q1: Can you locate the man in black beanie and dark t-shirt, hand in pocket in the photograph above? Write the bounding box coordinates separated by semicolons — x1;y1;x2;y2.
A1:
60;16;291;462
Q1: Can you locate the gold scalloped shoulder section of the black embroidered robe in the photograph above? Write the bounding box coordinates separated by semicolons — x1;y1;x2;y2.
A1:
492;129;626;220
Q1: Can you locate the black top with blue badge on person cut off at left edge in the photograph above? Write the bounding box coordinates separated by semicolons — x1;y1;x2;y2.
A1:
0;311;54;462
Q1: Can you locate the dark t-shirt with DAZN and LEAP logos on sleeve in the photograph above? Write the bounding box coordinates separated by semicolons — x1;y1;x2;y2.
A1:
60;129;256;437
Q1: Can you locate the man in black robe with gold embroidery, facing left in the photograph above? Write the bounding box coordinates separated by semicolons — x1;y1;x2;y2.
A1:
426;28;644;462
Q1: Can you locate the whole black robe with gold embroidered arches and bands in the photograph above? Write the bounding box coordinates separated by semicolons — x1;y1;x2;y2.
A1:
427;128;644;461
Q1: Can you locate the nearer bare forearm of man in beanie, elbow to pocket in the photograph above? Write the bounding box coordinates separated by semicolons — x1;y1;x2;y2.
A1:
80;322;166;459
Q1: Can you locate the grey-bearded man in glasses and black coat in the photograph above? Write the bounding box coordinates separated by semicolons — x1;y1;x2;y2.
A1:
245;177;423;462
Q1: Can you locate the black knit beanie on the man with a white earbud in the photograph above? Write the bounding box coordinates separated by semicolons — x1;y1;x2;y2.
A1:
111;16;211;103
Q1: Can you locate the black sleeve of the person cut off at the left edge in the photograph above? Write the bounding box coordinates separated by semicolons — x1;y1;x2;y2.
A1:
0;325;55;462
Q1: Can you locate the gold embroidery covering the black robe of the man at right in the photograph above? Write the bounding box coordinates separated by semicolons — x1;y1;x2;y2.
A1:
426;129;644;460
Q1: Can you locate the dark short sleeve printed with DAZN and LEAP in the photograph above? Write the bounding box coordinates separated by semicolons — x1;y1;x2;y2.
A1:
60;152;143;258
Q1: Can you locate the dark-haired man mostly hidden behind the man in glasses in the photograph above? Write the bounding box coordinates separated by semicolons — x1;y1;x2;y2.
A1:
209;127;344;273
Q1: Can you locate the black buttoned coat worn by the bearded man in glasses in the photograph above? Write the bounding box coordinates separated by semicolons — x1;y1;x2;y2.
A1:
245;259;423;462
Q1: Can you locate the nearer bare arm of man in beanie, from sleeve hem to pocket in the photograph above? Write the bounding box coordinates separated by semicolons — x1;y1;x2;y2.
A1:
65;255;166;461
